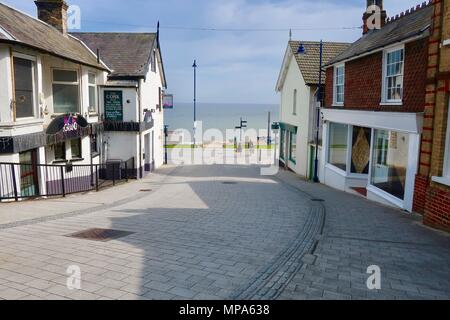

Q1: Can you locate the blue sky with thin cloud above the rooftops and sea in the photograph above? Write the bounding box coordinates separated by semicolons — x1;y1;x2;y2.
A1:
1;0;422;104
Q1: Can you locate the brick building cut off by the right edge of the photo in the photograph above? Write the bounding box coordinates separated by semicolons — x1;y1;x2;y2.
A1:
414;0;450;231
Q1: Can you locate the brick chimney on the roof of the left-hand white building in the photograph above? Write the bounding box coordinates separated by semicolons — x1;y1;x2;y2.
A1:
34;0;69;34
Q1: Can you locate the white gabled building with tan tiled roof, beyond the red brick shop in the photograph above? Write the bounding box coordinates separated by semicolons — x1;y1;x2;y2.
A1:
276;41;348;179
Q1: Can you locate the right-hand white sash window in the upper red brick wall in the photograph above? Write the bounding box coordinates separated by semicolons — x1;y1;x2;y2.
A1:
382;47;405;103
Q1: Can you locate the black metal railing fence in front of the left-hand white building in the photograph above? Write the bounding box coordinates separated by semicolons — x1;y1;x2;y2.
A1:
0;160;134;201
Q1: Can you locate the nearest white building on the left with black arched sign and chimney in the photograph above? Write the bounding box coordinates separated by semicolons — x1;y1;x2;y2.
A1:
0;1;109;197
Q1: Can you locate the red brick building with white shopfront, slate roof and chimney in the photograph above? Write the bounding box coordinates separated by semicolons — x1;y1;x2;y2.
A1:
322;0;434;212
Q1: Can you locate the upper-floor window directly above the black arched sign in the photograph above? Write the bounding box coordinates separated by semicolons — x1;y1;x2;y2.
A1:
53;70;80;114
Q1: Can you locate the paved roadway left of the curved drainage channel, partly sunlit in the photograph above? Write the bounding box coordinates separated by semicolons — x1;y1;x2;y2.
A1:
0;166;322;299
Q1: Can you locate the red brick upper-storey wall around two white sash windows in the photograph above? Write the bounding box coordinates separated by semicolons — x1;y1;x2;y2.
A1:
325;38;428;112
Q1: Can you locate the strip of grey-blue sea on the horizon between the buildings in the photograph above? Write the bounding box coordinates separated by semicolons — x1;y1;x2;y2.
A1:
164;103;279;135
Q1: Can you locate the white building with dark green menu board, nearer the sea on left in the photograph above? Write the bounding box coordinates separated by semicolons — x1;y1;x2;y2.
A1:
74;33;166;177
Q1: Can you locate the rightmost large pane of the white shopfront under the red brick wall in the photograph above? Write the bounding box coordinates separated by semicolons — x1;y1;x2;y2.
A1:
371;130;409;200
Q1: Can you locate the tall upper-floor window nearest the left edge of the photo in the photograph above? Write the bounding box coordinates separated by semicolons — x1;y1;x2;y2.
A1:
14;58;34;118
